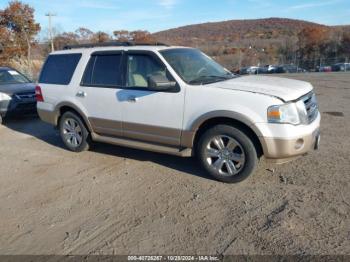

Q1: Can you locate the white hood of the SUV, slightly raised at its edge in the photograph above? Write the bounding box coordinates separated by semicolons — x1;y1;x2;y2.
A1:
211;76;313;102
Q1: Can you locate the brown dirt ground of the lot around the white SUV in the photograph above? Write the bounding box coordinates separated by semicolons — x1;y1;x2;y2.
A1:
0;73;350;255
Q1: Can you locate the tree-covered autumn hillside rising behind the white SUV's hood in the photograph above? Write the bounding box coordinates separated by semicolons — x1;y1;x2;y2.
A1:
153;18;350;69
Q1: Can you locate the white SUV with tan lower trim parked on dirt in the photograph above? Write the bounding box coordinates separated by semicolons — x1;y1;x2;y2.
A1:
36;43;320;182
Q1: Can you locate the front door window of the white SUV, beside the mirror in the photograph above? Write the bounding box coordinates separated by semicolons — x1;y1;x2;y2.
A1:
127;54;167;88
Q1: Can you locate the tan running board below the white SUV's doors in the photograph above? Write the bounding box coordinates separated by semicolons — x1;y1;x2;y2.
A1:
91;133;192;157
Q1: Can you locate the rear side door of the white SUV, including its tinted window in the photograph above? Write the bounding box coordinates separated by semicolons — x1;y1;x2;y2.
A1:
76;51;124;136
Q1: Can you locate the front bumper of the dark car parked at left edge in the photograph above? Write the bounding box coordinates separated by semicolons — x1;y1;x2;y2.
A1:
0;99;36;116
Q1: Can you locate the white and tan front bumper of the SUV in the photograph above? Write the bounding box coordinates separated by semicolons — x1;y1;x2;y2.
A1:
254;113;321;163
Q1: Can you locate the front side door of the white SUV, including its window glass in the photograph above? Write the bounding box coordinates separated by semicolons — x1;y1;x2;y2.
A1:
118;51;184;146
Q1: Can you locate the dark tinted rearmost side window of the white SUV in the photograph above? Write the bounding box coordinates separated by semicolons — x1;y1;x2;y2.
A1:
39;54;81;85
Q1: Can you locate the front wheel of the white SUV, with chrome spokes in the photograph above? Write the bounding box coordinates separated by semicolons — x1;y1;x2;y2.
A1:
197;125;258;183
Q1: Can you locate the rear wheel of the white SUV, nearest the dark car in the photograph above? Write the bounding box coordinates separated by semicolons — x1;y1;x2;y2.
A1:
59;111;90;152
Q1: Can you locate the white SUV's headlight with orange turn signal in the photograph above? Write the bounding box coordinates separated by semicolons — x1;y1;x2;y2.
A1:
267;101;308;125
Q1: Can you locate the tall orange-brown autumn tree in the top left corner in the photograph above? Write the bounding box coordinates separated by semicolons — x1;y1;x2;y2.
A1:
0;0;40;71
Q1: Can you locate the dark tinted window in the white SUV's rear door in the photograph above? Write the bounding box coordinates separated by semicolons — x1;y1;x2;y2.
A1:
82;54;122;87
